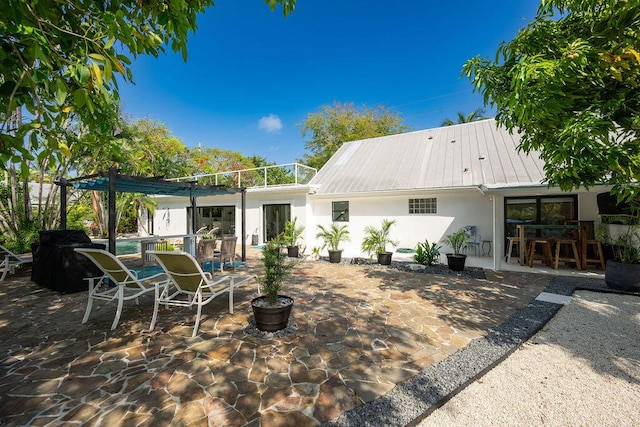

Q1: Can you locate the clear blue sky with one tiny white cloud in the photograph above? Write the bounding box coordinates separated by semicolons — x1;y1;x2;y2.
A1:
120;0;538;163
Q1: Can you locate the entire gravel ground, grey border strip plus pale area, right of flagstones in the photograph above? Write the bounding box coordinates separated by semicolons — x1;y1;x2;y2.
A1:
330;277;640;426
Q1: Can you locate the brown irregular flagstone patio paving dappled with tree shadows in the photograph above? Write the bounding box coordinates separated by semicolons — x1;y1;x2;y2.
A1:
0;254;550;426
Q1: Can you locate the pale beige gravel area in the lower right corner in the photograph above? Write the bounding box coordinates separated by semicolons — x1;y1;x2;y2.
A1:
419;291;640;427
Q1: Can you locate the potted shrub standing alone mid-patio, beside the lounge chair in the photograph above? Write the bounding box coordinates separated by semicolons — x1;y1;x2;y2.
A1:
251;239;293;332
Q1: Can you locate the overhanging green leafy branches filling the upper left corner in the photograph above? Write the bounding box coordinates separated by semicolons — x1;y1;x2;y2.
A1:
0;0;295;176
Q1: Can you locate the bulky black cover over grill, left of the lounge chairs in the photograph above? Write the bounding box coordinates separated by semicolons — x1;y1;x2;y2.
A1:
31;230;105;294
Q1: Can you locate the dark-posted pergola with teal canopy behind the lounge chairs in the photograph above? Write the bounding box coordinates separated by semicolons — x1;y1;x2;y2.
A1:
56;167;246;261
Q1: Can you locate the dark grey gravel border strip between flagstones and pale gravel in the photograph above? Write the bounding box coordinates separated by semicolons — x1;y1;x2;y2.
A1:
326;277;637;426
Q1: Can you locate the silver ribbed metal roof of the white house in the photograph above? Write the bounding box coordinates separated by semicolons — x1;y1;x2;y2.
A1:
310;119;544;194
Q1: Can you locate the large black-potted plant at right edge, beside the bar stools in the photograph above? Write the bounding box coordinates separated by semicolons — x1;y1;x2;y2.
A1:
600;215;640;291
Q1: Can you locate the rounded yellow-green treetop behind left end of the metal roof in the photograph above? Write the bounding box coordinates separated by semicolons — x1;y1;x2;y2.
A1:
301;102;410;169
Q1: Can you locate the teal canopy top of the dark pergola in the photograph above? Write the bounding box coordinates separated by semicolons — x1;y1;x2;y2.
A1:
69;175;242;197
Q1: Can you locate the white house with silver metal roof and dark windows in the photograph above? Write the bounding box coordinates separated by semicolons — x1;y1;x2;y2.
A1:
149;119;608;269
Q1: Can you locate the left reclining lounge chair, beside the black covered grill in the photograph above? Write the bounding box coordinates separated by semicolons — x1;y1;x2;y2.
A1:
74;248;163;330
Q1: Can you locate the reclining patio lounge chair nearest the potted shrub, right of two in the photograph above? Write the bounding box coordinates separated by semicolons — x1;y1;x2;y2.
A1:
149;251;255;337
